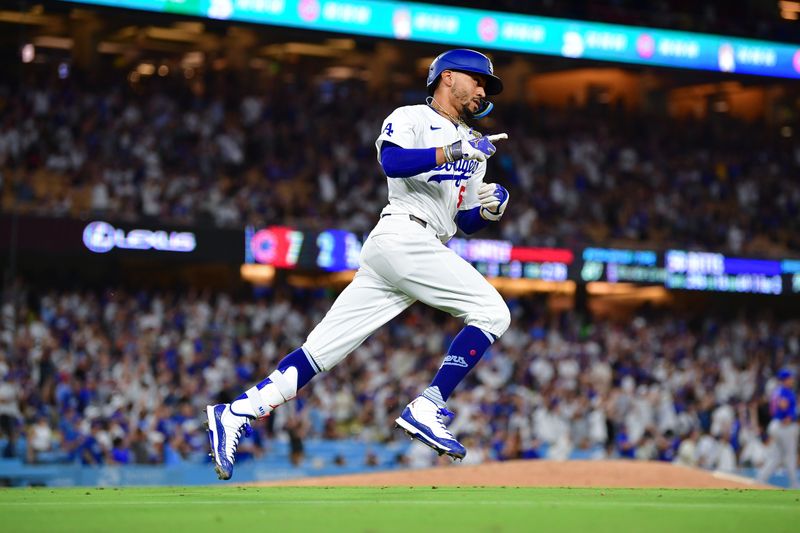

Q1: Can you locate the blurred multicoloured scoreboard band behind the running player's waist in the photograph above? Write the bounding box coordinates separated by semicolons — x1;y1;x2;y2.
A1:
245;226;800;295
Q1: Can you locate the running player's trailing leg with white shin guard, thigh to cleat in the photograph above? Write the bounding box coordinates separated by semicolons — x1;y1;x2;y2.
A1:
206;260;414;479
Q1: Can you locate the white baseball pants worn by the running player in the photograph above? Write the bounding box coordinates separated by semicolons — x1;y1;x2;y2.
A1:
303;215;511;370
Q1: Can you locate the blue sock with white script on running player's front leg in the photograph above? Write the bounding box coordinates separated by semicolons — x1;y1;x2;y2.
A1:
422;326;495;407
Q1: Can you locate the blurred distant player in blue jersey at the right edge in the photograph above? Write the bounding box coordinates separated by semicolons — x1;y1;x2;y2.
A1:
758;369;798;489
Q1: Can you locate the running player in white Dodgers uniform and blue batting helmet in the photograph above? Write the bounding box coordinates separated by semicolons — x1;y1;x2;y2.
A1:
206;49;511;479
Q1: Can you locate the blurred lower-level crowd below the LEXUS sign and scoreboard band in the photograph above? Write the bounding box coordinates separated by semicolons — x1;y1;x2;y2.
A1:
0;286;800;470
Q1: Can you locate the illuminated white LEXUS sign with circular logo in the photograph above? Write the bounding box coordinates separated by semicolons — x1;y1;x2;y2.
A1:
83;221;197;254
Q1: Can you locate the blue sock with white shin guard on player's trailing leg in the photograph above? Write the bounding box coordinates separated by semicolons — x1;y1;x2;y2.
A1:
231;348;320;418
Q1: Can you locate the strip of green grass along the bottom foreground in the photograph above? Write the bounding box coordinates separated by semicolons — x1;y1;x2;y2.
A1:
0;486;800;533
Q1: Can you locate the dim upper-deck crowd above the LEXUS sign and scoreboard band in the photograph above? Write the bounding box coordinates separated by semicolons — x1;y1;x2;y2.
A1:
0;78;800;256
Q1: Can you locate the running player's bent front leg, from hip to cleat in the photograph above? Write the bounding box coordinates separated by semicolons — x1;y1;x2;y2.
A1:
370;222;511;458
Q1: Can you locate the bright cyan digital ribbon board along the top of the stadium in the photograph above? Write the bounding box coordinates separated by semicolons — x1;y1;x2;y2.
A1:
62;0;800;79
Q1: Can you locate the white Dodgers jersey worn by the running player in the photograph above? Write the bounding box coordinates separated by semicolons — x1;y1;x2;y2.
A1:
375;104;486;242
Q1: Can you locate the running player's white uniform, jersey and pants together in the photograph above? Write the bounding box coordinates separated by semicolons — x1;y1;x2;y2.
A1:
303;105;511;370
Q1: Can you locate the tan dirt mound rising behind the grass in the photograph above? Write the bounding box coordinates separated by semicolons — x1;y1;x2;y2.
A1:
257;461;774;489
